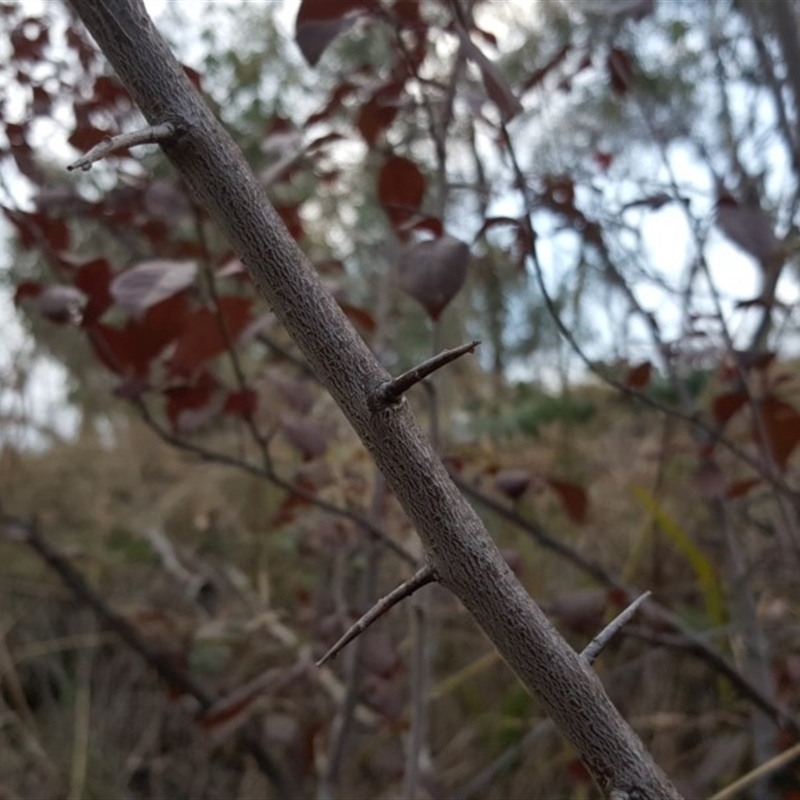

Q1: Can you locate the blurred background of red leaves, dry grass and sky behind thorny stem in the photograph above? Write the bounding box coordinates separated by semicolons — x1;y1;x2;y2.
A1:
0;0;800;800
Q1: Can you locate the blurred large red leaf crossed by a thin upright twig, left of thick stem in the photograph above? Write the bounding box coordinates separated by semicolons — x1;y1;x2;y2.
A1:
170;296;252;374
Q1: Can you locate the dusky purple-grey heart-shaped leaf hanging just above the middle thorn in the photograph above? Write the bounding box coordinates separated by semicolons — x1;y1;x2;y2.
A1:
398;236;469;320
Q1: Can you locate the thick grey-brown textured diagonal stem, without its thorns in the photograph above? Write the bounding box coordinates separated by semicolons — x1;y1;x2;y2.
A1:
65;0;679;800
